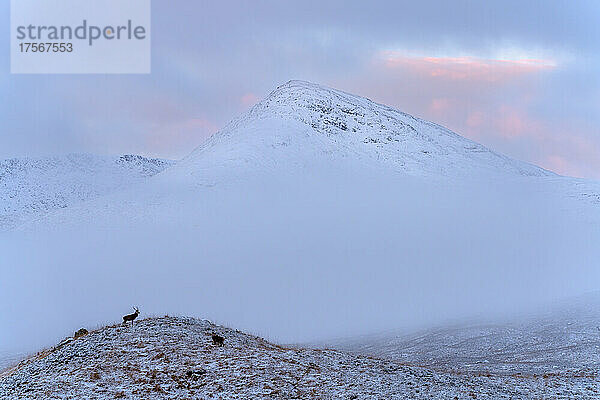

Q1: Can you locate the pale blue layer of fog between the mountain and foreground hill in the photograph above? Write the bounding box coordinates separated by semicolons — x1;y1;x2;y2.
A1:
0;170;600;362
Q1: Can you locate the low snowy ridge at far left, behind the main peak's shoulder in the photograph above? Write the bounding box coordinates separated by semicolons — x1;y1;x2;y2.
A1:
0;154;173;229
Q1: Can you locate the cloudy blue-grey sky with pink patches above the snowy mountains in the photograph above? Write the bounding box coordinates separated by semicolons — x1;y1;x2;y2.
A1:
0;0;600;178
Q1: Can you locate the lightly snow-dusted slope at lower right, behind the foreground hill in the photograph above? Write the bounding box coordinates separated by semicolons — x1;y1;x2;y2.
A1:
325;294;600;374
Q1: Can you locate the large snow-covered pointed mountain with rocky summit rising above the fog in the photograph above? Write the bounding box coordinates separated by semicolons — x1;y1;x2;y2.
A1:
12;81;600;229
